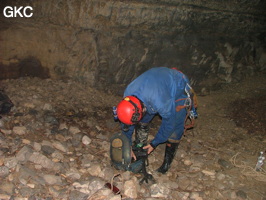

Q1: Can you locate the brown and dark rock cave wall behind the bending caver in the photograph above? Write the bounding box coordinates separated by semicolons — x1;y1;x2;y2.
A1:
0;0;266;92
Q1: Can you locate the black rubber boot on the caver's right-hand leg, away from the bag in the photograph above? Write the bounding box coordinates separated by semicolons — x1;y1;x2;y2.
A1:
157;142;179;174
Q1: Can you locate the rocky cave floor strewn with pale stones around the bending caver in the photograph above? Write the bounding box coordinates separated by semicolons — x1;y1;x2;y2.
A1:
0;74;266;200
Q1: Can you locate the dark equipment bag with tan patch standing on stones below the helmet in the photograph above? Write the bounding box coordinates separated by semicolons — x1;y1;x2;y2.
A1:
110;133;143;173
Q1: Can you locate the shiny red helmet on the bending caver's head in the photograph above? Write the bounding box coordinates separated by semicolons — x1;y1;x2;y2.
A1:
117;96;142;125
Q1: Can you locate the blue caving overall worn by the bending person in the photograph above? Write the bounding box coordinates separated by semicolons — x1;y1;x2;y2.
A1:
122;67;193;147
